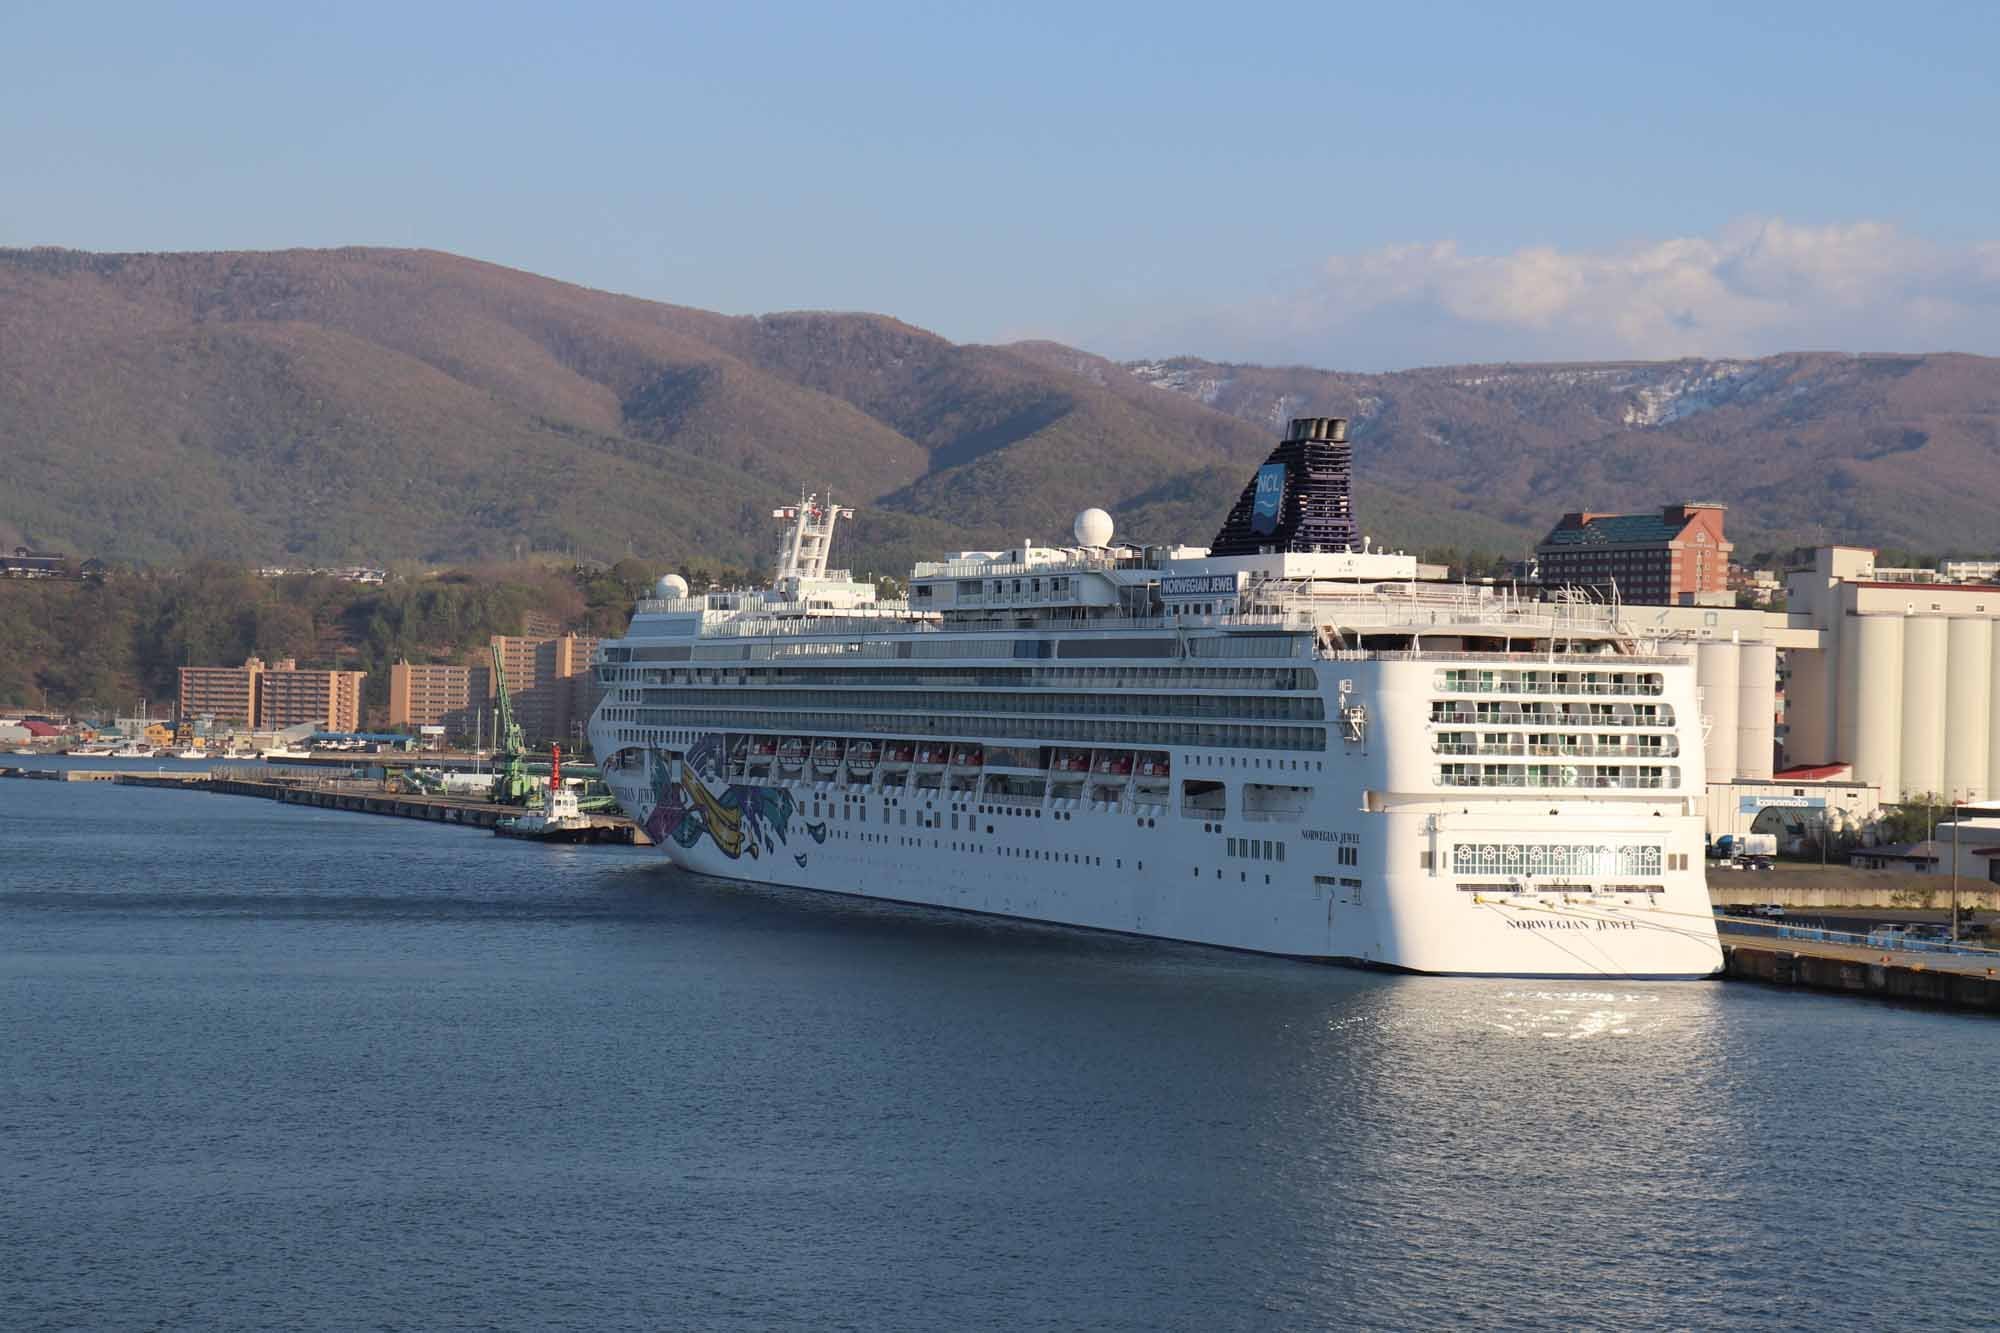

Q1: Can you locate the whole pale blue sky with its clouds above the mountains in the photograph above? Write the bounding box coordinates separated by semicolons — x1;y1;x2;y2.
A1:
0;0;2000;368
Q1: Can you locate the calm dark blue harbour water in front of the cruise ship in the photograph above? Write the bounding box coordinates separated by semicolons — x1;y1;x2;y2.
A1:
0;764;2000;1329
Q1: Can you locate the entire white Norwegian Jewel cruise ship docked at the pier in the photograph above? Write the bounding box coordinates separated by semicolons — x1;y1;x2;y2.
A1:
590;418;1722;979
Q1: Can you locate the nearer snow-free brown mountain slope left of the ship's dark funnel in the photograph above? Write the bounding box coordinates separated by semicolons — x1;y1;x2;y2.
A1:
0;250;1408;568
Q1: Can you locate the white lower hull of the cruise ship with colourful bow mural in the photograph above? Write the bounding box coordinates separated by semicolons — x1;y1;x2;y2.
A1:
588;745;1722;979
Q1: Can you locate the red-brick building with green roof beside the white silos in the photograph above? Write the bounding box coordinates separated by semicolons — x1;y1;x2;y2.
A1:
1534;502;1736;606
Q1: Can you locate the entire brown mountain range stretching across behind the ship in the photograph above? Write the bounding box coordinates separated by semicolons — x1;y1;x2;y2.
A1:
0;248;2000;572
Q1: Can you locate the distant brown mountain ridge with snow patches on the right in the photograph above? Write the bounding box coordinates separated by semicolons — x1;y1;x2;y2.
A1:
1128;352;2000;552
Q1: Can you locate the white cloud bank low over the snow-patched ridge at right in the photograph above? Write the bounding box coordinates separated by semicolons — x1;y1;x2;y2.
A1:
1146;218;2000;370
